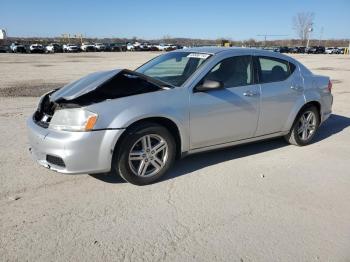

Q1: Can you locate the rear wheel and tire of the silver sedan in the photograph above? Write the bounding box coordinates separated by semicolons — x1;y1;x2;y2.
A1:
284;106;320;146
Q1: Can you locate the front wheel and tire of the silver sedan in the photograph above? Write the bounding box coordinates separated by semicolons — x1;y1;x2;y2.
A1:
112;123;176;186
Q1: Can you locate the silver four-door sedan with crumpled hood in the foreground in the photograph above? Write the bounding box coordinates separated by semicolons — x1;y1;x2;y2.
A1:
27;47;333;185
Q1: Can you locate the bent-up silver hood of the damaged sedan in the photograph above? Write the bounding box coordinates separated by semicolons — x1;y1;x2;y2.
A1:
50;69;122;101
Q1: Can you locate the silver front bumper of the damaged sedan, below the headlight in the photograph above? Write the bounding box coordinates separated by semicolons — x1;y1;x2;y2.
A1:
27;118;124;174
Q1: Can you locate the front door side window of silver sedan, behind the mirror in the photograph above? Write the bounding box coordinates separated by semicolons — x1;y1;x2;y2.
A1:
204;56;253;87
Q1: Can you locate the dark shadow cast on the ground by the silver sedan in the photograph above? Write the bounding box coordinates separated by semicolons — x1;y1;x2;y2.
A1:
91;114;350;183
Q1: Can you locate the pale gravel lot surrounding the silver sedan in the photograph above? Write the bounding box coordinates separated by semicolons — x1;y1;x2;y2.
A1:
0;52;350;262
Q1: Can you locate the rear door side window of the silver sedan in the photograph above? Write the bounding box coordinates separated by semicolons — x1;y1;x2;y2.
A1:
258;57;295;83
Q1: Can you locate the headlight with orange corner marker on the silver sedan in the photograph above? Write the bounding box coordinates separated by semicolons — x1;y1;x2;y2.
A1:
49;108;97;131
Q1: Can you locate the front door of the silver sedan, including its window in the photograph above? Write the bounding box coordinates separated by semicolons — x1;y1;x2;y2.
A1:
190;55;260;149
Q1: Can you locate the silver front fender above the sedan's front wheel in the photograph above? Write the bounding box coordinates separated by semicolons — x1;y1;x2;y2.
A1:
86;87;189;152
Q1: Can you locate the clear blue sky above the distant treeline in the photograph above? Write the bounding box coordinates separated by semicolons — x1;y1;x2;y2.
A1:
0;0;350;40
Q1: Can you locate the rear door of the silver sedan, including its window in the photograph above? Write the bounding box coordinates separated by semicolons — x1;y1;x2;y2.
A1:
254;56;303;136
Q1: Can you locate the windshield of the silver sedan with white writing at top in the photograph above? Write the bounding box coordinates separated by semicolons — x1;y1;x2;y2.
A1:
136;52;211;86
